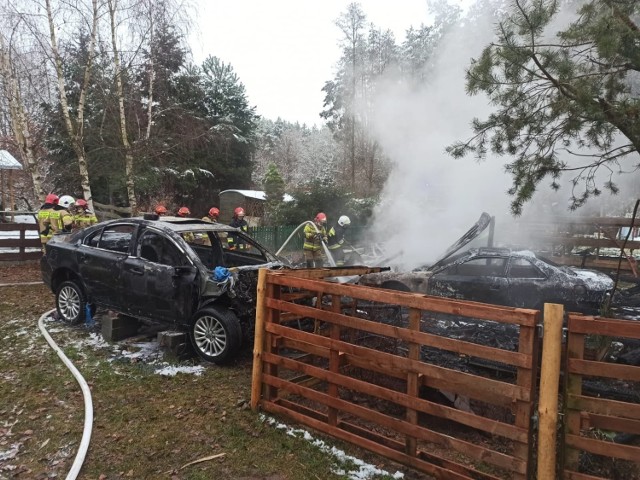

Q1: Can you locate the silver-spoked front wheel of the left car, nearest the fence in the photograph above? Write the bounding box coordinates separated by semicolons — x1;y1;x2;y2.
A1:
189;308;242;364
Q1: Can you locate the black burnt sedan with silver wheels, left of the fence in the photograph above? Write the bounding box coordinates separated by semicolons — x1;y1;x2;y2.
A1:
41;216;284;363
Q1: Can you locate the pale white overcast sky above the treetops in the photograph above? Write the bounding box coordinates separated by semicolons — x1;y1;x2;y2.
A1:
191;0;440;125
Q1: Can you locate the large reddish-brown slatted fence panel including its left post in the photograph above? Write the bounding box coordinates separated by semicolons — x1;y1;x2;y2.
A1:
252;269;540;479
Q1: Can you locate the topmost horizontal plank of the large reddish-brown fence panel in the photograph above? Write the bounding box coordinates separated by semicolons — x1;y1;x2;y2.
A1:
268;272;539;327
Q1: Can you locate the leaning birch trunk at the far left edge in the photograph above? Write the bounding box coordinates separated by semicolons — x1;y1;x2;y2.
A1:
0;33;45;202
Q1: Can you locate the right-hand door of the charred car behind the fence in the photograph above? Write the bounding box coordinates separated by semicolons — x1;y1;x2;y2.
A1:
507;257;558;309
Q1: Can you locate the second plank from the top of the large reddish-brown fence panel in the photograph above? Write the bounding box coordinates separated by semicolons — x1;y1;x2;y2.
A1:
265;298;532;369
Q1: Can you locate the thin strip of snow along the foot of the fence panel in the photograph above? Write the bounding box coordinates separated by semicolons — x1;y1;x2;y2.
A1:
260;414;404;480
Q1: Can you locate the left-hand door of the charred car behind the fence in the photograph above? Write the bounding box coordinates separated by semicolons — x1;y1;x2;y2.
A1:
428;256;508;305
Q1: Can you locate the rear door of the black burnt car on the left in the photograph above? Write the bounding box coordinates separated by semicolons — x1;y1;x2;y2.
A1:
78;224;136;309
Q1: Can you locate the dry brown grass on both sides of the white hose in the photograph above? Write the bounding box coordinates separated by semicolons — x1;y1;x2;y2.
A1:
0;285;408;480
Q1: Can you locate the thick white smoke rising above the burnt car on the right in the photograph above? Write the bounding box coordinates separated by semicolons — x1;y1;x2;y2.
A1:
364;0;637;269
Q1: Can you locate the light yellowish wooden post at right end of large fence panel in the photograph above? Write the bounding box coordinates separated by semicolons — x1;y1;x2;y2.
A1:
538;303;564;480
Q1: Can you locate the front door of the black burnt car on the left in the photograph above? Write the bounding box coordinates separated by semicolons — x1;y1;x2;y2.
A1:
122;228;197;322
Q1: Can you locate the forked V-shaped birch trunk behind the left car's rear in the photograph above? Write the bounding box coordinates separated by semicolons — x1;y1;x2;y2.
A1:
45;0;98;210
